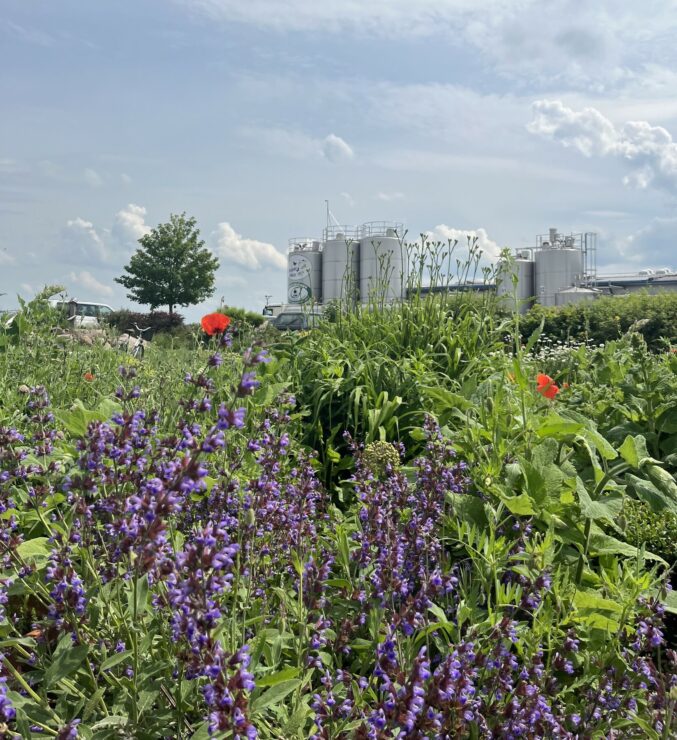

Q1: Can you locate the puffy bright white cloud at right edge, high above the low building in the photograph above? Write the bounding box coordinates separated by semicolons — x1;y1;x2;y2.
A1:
527;100;677;192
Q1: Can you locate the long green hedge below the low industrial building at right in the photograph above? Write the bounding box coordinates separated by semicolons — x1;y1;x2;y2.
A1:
520;293;677;349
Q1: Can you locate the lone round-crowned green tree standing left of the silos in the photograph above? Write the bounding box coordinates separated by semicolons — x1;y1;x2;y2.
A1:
115;213;219;314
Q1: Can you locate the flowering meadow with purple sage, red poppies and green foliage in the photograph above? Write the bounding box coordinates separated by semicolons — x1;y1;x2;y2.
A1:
0;282;677;740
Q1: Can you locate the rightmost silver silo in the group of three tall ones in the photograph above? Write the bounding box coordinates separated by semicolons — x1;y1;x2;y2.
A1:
360;221;408;303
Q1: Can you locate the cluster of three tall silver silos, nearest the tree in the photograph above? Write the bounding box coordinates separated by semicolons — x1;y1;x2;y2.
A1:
287;221;408;305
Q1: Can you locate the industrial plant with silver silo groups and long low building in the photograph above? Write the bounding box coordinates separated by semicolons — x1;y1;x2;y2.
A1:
287;221;677;312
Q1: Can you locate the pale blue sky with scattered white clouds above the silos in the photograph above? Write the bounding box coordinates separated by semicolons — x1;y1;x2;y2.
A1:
0;0;677;319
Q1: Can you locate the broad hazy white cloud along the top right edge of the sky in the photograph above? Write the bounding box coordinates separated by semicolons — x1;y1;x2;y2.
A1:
174;0;677;91
